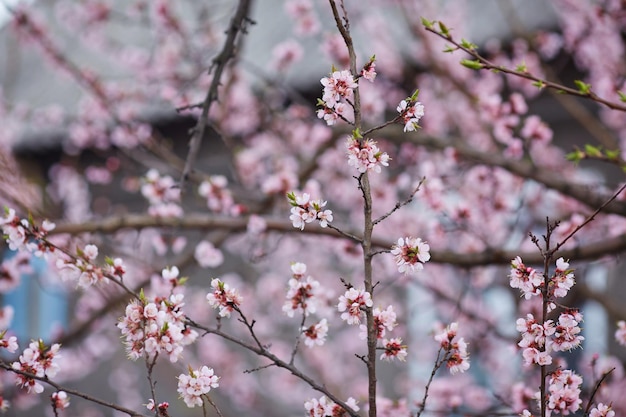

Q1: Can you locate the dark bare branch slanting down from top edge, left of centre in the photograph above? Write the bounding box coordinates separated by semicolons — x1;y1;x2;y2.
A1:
180;0;252;188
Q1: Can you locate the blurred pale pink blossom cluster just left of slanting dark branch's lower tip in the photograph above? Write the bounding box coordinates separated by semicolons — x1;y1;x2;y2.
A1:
141;169;183;217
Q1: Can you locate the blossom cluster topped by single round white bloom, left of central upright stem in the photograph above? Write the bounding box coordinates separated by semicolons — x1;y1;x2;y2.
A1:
283;262;320;317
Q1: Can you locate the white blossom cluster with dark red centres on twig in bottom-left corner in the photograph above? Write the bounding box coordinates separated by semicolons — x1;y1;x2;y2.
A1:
11;339;61;394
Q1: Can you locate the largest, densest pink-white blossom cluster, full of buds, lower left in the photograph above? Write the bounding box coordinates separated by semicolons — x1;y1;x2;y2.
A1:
117;280;198;362
